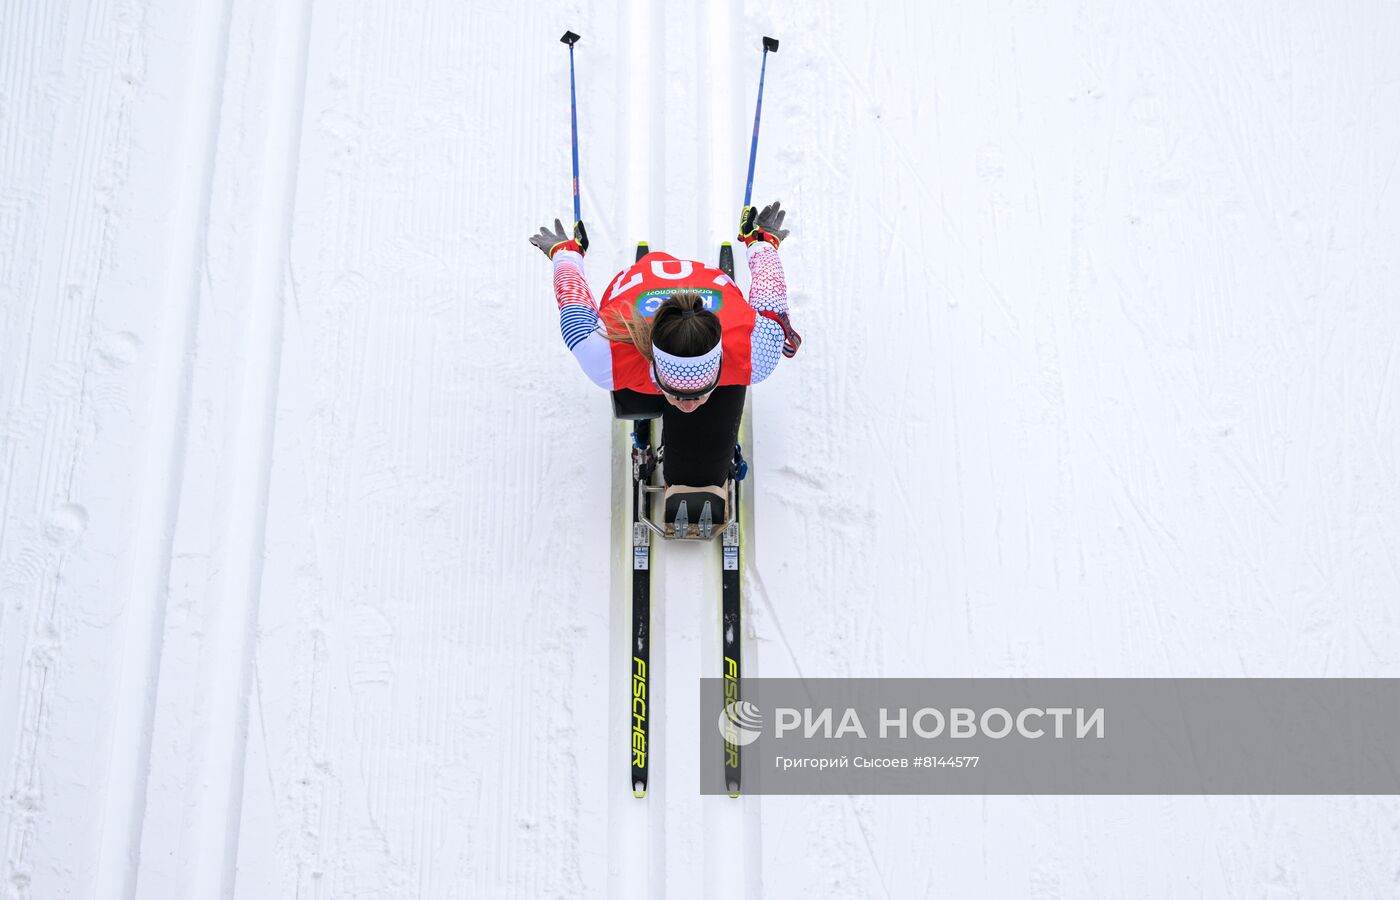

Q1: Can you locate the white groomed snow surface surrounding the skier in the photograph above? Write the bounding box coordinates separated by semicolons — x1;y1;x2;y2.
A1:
0;0;1400;900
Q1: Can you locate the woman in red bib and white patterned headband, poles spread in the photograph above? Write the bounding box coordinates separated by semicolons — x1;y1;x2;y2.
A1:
531;203;802;486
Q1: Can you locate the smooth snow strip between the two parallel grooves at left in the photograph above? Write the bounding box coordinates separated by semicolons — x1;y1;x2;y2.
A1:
116;3;319;896
